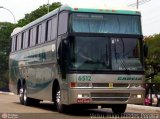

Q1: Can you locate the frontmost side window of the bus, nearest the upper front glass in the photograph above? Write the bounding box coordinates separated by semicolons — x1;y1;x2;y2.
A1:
58;11;68;35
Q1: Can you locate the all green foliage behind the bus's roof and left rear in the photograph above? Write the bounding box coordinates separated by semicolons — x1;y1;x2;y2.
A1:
0;2;61;90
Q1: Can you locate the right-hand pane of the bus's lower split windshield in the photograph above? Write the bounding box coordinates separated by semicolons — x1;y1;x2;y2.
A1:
111;38;143;71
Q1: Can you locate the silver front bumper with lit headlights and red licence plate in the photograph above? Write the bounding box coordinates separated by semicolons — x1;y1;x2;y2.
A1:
68;88;145;104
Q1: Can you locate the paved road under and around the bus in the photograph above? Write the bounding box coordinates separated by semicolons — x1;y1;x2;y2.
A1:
0;93;160;119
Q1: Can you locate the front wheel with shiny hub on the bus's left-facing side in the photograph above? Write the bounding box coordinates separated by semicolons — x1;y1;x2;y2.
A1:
56;88;65;113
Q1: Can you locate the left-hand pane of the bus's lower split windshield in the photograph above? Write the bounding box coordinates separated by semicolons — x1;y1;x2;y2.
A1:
70;37;109;70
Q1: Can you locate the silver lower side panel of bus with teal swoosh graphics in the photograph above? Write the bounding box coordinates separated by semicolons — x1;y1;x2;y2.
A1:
10;41;58;100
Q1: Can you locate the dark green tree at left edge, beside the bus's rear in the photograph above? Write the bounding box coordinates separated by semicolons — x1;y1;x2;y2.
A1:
0;22;15;89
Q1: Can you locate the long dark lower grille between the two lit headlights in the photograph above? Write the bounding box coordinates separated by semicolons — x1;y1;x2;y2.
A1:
91;93;130;101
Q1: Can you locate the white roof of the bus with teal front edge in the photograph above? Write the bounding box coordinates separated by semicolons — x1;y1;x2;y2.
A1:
11;5;140;36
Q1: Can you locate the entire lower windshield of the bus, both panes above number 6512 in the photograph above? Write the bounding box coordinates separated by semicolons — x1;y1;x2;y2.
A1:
69;36;143;71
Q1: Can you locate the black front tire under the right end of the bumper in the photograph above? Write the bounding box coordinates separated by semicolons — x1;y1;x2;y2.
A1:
112;104;127;114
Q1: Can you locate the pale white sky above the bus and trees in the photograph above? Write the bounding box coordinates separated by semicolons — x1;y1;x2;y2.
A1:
0;0;160;36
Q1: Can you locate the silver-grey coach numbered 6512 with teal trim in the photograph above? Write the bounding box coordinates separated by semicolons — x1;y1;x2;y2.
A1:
9;5;145;114
